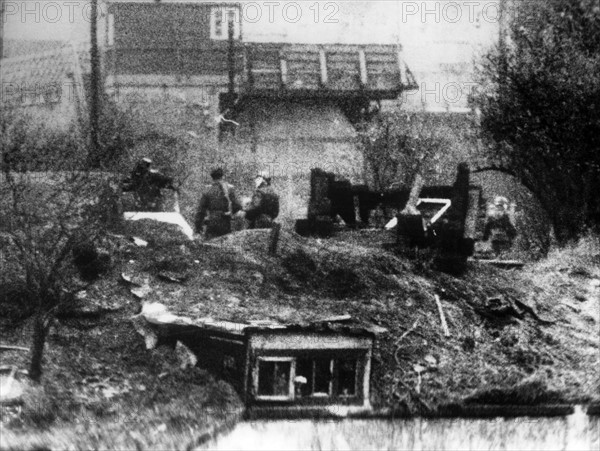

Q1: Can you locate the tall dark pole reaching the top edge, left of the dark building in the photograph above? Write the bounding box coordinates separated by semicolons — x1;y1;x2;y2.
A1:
88;0;101;161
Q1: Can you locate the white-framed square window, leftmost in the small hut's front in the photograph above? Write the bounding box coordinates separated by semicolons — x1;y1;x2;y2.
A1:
255;357;294;401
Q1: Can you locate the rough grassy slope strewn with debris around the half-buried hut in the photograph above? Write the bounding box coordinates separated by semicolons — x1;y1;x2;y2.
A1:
1;228;600;448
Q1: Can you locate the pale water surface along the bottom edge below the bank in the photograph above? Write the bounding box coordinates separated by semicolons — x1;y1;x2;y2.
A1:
206;408;600;451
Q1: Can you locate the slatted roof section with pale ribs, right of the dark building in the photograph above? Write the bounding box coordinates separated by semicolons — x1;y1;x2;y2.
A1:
245;42;415;98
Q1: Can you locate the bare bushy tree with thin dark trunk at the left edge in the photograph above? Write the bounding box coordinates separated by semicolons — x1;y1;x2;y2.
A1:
0;112;117;381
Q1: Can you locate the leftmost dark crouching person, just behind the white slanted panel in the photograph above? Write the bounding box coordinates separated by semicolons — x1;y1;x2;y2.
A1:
123;158;176;211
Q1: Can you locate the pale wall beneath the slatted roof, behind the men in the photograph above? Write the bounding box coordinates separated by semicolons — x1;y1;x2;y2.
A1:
220;99;364;222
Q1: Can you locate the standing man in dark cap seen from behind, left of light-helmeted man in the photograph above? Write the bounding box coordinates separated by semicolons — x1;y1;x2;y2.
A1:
194;168;242;240
